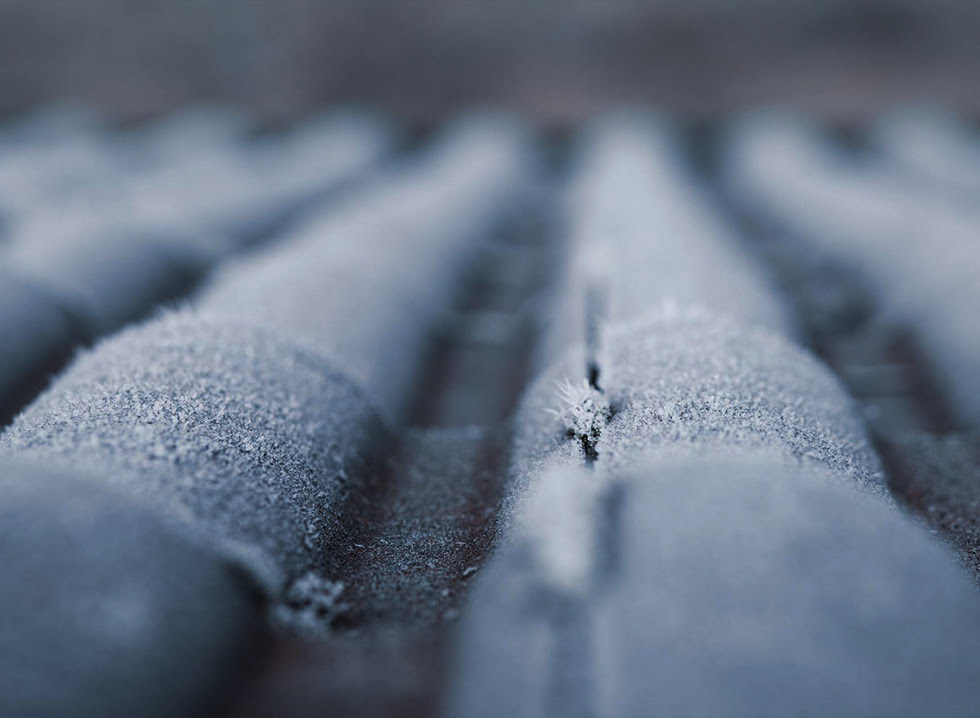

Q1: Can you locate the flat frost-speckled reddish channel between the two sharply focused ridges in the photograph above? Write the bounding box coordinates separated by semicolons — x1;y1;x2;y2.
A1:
332;427;516;632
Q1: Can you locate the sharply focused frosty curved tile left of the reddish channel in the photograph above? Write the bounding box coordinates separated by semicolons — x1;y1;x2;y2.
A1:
0;312;386;577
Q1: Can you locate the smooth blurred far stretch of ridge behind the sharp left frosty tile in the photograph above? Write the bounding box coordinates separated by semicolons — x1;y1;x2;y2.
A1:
198;113;533;418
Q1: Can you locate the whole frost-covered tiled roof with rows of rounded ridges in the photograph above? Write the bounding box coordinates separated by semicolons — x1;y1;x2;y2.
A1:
0;107;980;718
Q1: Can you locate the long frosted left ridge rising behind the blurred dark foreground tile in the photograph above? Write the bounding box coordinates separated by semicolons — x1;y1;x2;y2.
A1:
0;115;530;579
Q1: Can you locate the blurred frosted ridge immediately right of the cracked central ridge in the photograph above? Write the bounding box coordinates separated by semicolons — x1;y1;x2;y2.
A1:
727;112;980;426
